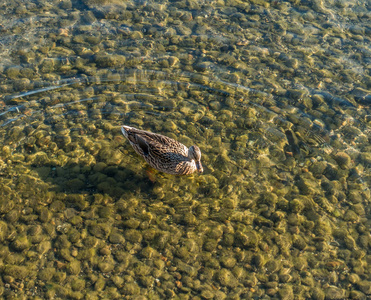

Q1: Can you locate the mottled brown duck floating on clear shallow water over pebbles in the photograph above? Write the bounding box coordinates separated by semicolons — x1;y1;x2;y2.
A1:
121;126;203;175
